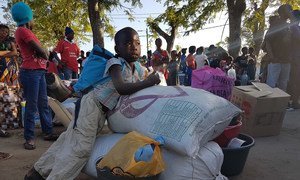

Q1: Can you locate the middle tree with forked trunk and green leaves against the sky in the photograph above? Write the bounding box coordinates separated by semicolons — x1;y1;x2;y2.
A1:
147;0;225;52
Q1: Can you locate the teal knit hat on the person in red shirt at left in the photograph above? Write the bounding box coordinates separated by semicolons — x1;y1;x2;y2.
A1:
11;2;33;26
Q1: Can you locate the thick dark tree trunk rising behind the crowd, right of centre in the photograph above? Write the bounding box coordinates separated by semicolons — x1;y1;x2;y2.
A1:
227;0;246;58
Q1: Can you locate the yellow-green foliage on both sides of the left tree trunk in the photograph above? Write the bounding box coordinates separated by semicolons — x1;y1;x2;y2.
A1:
2;0;142;47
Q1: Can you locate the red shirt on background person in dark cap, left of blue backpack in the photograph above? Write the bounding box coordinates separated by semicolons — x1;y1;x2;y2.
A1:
54;39;80;72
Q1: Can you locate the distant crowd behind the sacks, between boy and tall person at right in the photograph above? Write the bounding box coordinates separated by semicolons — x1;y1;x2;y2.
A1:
140;38;257;86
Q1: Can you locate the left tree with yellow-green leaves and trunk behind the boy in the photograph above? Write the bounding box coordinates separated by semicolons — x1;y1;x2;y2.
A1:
3;0;142;47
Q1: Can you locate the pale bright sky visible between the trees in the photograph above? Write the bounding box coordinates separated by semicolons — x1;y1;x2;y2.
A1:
0;0;229;55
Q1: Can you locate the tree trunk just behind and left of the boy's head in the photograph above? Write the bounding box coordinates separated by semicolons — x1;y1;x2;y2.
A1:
88;0;104;47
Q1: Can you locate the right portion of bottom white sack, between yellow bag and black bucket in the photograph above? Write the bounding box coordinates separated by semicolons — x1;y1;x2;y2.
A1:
159;141;227;180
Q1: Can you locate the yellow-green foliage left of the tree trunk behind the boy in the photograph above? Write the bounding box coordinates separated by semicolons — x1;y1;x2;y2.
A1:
8;0;91;47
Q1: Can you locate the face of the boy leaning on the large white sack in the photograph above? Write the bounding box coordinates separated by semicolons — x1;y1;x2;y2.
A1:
116;32;141;62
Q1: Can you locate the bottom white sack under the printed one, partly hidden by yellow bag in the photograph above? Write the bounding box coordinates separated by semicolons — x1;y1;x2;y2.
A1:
82;133;227;180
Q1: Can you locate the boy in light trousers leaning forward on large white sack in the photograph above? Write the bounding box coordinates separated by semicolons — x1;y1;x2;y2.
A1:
25;27;160;179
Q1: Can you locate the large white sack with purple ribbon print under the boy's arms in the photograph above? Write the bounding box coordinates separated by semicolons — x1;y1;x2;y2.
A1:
108;86;241;157
